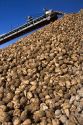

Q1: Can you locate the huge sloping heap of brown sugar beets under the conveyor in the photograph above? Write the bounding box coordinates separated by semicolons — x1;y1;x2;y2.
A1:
0;11;83;125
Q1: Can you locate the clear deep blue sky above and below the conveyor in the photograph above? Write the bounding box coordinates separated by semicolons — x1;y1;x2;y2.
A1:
0;0;83;48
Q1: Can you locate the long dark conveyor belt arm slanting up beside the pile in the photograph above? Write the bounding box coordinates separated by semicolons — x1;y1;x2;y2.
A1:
0;10;62;45
